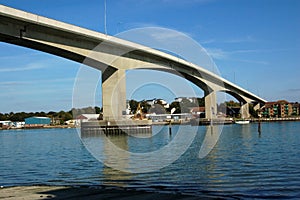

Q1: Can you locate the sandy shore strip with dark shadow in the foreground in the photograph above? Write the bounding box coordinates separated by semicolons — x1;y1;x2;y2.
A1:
0;185;202;200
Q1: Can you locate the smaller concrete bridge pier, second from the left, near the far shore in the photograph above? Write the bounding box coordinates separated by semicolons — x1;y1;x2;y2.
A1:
205;91;217;119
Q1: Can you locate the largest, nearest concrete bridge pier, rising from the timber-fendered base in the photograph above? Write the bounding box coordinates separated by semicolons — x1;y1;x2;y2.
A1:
102;69;126;120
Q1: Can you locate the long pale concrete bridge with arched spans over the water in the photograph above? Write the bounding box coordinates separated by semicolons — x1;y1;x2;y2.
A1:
0;5;266;119
